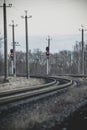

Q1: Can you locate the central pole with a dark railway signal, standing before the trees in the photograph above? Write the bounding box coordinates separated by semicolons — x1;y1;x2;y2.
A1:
46;36;52;75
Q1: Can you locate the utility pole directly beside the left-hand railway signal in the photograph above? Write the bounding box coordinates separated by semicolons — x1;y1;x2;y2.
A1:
9;20;18;76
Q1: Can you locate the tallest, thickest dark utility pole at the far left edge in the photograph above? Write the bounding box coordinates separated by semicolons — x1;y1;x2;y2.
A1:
0;0;12;81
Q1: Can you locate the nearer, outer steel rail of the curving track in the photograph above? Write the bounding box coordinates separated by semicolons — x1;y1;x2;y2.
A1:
0;78;73;104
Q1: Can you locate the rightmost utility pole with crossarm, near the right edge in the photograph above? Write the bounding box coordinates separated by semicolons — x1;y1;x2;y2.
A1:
79;25;86;75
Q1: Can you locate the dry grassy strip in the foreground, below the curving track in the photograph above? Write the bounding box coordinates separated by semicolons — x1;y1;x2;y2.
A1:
0;79;87;130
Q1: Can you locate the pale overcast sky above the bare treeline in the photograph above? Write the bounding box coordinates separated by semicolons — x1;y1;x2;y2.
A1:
0;0;87;52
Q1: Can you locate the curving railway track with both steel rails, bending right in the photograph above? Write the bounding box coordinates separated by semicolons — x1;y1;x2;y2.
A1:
0;77;73;105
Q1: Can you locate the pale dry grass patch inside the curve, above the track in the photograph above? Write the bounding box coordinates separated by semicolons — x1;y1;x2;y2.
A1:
0;77;45;92
